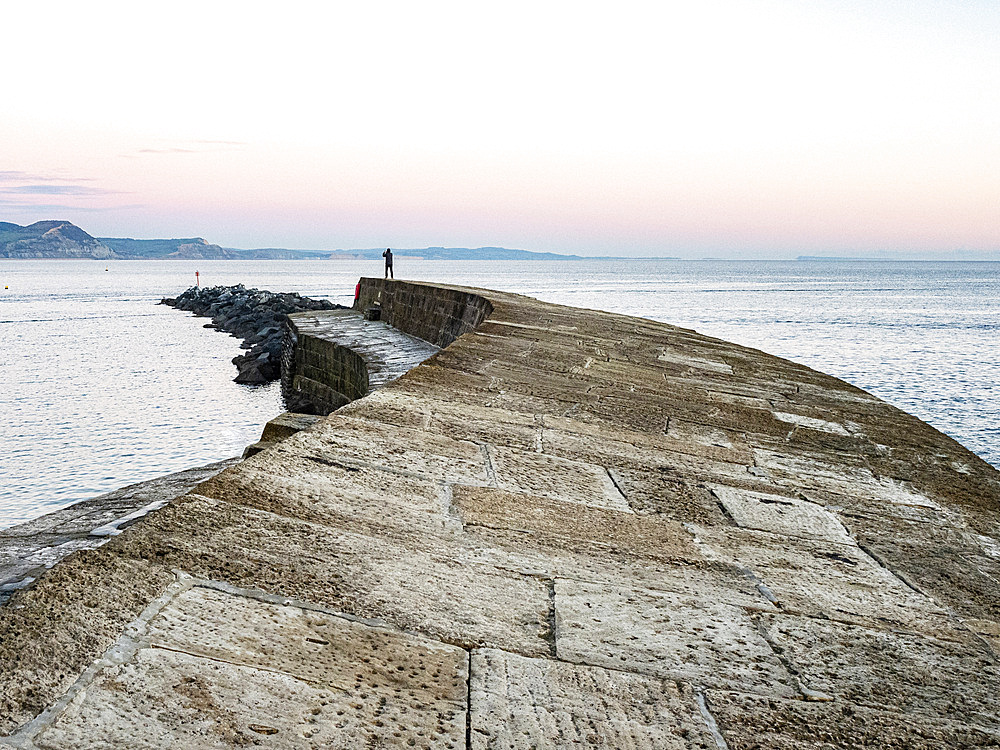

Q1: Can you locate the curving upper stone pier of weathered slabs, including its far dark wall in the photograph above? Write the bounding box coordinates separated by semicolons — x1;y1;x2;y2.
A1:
0;279;1000;750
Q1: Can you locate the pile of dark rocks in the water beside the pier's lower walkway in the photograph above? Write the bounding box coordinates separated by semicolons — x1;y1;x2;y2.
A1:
160;284;343;384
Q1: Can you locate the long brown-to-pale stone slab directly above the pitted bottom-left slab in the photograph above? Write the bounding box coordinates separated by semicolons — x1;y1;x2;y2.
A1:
115;500;551;654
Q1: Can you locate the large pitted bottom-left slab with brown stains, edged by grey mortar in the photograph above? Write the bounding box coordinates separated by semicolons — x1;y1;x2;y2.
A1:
35;587;468;750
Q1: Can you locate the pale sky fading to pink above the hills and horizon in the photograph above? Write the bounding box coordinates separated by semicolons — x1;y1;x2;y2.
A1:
0;0;1000;259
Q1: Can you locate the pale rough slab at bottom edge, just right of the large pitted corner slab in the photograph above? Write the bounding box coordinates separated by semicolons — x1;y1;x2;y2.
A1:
469;649;717;750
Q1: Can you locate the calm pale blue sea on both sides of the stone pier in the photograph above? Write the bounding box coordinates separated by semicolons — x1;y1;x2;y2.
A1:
0;256;1000;527
